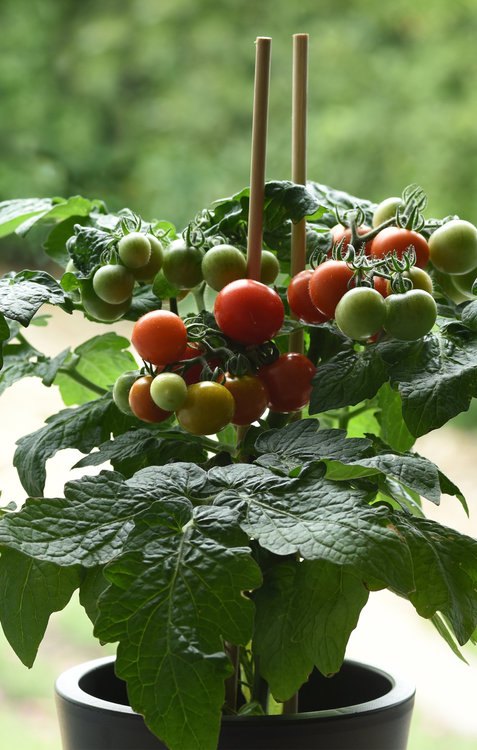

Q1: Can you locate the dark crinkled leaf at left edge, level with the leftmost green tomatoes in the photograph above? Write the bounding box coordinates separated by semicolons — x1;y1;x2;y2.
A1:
0;271;73;326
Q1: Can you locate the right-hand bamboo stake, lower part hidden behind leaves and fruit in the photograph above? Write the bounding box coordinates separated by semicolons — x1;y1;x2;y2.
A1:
290;34;308;353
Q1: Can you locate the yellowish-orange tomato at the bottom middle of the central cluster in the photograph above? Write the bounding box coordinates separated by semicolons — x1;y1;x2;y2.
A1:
176;380;235;435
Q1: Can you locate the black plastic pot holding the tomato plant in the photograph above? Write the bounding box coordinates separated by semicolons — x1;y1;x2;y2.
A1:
56;657;414;750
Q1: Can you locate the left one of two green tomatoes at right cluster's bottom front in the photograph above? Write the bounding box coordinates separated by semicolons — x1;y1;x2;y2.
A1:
335;286;386;341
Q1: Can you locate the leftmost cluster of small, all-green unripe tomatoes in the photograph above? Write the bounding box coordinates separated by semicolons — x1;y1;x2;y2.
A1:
81;232;164;322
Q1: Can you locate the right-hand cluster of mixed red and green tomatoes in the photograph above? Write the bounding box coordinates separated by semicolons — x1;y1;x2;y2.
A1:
287;198;477;341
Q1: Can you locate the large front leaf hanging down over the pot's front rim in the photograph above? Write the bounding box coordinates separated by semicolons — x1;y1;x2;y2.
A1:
95;502;261;750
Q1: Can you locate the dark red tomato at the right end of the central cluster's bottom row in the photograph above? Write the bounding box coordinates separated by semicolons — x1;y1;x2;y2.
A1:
258;352;316;413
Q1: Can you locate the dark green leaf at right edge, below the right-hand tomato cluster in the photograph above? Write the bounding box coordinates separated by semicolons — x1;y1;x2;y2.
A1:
377;328;477;437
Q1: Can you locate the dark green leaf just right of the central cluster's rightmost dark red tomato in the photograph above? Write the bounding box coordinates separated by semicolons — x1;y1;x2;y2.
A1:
309;345;388;414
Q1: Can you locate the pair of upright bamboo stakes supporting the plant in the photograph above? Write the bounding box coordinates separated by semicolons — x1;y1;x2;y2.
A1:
247;34;308;352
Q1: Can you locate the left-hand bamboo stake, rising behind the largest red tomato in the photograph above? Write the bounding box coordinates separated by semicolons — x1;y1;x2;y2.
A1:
247;37;272;280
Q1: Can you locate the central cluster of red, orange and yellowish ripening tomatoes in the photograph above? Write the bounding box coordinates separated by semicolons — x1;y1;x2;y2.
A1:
113;279;316;435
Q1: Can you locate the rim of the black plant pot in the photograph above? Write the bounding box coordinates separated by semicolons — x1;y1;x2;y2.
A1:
55;655;415;723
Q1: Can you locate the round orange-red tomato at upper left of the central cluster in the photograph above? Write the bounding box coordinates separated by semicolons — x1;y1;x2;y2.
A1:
131;310;187;365
